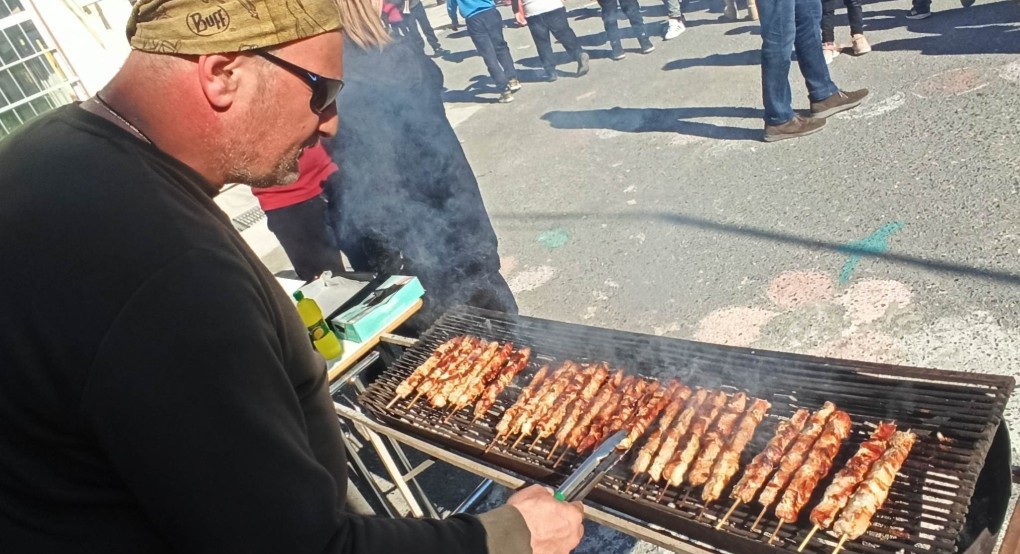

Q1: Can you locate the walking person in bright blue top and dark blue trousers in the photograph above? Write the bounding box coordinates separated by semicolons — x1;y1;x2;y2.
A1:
447;0;522;104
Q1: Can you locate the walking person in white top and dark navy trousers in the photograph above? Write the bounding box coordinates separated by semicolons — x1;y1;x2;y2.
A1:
515;0;589;82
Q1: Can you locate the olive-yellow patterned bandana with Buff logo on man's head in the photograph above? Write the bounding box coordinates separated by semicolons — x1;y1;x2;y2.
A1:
128;0;343;55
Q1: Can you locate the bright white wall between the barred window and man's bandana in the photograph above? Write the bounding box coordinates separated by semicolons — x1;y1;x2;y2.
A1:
32;0;131;95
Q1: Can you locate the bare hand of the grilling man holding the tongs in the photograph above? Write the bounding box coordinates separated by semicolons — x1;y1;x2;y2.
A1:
507;485;584;554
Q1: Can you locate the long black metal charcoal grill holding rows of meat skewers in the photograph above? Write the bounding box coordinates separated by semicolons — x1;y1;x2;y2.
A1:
358;307;1015;554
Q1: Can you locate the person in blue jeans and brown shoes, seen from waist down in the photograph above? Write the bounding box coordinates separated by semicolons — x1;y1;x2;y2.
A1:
758;0;868;142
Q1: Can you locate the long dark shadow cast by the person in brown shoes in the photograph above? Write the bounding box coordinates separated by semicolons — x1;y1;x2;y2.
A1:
542;107;764;141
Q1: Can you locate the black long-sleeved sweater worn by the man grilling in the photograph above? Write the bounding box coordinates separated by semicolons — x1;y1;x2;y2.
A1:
0;106;518;554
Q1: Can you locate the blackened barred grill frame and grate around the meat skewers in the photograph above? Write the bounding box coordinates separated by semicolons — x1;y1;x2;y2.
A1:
359;307;1015;554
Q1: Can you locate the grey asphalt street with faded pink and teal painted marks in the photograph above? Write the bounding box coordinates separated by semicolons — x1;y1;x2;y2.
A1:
231;0;1020;554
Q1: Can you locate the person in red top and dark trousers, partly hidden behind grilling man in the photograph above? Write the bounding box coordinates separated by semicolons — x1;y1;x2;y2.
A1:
252;143;344;281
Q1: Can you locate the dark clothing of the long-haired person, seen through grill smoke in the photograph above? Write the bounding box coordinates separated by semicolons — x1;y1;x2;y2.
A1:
326;38;516;330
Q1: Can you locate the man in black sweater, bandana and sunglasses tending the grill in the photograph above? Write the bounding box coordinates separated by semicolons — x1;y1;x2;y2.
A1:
0;0;582;554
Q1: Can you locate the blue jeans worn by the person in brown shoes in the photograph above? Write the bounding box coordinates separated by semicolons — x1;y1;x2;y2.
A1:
758;0;839;125
